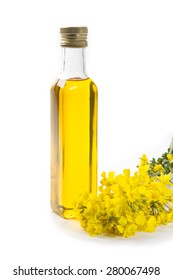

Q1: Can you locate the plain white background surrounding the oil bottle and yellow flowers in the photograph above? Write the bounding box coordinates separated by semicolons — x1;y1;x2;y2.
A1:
0;0;173;280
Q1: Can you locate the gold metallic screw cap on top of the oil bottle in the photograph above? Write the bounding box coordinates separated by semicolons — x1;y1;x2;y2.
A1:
60;26;88;48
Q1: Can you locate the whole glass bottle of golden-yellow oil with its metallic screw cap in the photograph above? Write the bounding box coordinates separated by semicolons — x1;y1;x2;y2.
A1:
51;27;98;219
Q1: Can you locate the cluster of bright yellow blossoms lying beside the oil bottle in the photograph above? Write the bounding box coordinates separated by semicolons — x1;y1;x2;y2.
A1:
75;155;173;237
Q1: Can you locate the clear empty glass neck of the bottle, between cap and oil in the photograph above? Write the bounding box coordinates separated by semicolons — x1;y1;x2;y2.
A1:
60;48;87;79
